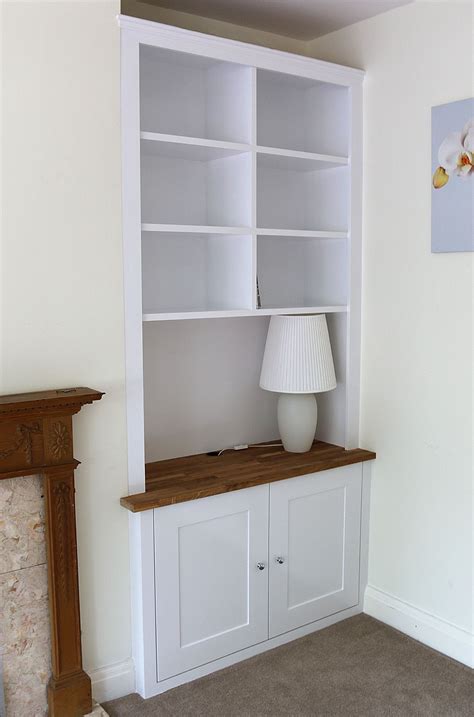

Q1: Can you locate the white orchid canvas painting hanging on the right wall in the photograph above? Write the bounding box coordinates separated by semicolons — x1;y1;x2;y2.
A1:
431;98;474;252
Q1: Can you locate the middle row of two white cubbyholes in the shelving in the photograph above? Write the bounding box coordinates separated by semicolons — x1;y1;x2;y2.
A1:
141;132;350;232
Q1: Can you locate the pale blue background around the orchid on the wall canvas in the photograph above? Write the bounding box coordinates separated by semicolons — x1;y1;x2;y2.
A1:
431;98;474;252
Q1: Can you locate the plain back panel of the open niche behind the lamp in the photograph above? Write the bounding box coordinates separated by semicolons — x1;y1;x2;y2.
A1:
143;314;347;462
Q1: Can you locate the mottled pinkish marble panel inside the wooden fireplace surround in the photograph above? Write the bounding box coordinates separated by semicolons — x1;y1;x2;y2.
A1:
0;476;107;717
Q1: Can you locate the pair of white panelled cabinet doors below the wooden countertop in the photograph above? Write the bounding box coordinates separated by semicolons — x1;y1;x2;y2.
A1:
154;464;362;681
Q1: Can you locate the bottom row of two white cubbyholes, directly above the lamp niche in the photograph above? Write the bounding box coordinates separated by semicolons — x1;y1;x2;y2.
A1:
142;227;348;321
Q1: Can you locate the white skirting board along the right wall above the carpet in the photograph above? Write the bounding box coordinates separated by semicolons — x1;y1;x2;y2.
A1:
364;585;474;668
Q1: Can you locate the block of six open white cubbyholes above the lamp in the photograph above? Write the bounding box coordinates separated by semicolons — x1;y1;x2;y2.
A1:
138;44;351;321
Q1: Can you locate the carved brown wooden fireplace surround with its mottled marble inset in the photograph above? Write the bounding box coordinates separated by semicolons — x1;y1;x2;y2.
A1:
0;388;106;717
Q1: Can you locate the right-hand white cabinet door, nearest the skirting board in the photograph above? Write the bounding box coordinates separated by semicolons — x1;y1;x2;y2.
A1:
269;465;362;637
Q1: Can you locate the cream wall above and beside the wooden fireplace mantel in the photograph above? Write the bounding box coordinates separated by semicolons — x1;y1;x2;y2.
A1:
0;0;130;692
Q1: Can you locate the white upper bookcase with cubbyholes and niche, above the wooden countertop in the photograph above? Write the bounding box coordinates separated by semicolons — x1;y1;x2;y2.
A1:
120;17;363;498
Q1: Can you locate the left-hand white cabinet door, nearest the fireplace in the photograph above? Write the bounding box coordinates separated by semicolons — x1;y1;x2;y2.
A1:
155;486;269;680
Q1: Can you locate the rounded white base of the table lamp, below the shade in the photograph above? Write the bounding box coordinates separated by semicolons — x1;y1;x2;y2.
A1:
278;393;318;453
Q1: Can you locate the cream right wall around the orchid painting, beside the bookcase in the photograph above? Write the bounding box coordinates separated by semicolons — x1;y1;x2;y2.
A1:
309;2;474;640
